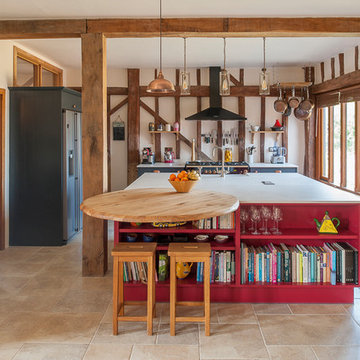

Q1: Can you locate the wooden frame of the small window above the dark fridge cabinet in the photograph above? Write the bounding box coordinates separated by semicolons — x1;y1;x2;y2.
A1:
13;46;63;86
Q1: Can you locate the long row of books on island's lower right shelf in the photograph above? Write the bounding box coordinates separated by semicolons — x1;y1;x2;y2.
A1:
240;242;359;285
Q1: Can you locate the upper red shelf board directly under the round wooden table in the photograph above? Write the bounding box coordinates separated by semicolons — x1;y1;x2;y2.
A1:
119;223;235;234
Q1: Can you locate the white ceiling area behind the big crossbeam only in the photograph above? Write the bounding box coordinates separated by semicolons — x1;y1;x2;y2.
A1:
17;37;360;68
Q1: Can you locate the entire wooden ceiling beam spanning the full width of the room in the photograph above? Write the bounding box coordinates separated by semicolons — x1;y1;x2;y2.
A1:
0;17;360;39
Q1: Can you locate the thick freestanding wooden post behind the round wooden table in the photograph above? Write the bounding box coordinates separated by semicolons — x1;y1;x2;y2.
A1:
81;33;108;276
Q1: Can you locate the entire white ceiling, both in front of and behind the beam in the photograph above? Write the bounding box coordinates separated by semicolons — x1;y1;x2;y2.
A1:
4;0;360;68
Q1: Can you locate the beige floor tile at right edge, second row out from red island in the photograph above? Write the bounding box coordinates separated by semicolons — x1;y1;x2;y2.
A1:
258;315;360;345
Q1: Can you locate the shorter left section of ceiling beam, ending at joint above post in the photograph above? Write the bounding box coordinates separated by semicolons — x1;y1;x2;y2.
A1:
0;19;87;39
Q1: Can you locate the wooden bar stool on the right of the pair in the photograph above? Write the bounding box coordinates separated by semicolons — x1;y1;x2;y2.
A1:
168;243;211;336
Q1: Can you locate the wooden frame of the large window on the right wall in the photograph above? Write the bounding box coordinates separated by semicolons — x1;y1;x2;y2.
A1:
316;100;360;194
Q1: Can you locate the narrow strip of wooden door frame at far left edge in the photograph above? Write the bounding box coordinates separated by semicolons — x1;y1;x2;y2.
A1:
0;89;6;250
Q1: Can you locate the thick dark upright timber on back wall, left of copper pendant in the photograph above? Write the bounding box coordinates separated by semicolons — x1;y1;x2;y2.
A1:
127;69;140;184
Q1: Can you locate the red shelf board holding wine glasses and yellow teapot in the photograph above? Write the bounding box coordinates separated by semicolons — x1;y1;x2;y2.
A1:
240;228;358;241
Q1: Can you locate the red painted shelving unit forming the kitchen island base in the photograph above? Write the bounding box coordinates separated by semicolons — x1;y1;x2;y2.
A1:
114;203;360;303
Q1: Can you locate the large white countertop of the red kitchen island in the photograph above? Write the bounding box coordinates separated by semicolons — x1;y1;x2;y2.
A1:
126;173;360;203
